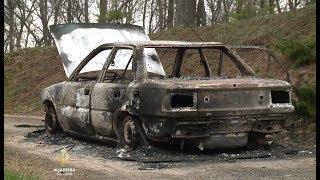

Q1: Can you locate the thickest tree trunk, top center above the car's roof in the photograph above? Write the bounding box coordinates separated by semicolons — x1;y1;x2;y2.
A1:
176;0;196;26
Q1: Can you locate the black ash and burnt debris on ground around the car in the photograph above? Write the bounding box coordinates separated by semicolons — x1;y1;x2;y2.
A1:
24;128;315;166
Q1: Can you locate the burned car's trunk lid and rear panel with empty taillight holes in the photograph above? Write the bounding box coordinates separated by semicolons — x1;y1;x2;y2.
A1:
140;78;291;118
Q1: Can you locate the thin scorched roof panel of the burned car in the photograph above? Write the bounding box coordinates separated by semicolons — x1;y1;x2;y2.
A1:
103;41;225;48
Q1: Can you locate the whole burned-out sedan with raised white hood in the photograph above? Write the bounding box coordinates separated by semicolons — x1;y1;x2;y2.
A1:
42;24;294;149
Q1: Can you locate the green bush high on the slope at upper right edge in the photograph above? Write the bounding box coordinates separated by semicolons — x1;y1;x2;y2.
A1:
275;38;316;67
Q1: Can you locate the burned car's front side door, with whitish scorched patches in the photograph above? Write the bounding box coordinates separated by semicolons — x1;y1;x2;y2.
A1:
60;49;111;135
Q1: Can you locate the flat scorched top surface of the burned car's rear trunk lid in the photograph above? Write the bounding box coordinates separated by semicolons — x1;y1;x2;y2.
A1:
144;77;291;90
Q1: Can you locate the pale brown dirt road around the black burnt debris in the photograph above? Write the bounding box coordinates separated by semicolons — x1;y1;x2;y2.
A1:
4;116;316;179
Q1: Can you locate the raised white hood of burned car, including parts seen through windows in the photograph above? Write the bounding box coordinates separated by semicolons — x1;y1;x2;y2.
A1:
50;23;165;78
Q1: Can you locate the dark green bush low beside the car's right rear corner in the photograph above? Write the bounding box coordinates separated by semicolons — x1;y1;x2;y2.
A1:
293;85;316;117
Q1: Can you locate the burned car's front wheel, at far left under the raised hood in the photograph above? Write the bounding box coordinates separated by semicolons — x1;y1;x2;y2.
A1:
45;106;62;136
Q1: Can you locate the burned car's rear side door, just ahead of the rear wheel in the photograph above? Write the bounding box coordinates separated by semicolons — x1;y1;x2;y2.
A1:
91;48;135;137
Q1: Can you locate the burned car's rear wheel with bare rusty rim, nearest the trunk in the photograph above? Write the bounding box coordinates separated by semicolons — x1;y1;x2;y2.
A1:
121;116;142;149
